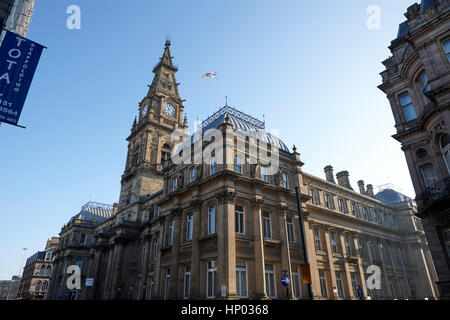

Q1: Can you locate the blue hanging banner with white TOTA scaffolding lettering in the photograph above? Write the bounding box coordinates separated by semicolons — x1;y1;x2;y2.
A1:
0;30;44;125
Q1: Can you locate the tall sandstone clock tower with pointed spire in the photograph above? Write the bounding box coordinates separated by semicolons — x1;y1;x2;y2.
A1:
119;40;187;207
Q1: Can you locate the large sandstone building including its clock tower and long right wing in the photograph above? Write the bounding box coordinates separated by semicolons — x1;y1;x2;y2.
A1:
49;41;436;300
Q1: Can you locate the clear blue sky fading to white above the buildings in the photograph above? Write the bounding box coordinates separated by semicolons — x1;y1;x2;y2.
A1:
0;0;414;279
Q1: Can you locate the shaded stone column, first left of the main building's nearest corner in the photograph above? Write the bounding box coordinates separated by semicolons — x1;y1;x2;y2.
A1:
190;200;202;300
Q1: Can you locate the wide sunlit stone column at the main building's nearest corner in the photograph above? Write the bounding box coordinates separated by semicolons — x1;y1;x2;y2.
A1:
216;188;237;299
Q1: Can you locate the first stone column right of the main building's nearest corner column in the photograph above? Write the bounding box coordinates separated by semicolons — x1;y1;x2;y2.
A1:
252;195;268;299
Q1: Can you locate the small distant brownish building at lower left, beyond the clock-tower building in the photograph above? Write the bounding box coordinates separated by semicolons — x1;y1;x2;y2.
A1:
17;237;59;300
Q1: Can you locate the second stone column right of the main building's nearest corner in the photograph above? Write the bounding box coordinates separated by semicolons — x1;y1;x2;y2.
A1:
278;202;294;299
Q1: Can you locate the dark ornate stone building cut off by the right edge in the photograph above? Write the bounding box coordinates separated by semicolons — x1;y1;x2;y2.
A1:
379;0;450;299
